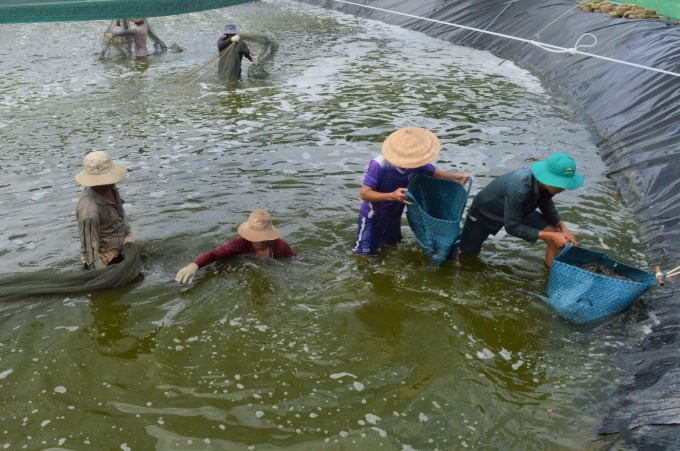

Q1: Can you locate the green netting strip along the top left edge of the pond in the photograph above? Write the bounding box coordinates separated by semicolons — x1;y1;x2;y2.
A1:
0;0;253;23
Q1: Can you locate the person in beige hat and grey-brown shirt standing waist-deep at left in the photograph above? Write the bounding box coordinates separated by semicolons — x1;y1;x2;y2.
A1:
75;151;134;269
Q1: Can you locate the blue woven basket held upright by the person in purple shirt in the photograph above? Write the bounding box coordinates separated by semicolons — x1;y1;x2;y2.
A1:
406;174;472;266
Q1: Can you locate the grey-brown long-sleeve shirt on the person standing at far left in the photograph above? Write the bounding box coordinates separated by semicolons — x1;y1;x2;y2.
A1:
76;187;131;269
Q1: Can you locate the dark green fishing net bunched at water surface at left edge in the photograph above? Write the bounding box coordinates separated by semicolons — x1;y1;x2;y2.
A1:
0;243;142;300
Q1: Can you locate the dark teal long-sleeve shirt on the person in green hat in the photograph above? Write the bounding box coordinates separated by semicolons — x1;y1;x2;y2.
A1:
470;168;562;243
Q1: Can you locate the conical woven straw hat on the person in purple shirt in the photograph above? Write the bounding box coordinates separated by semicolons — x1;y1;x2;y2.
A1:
382;127;441;168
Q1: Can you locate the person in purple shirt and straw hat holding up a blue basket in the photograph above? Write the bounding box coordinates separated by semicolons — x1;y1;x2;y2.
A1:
352;127;468;255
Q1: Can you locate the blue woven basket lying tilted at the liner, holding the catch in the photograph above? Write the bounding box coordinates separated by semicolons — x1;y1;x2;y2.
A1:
548;243;657;324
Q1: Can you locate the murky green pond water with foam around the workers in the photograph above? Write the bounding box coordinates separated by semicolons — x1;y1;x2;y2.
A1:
0;1;649;450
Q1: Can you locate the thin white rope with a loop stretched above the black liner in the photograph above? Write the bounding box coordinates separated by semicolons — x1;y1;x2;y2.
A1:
332;0;680;77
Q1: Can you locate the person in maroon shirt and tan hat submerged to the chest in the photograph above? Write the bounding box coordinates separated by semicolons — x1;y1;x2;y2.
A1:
175;209;297;283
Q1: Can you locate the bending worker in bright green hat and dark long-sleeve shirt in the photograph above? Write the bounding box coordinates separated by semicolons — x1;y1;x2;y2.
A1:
460;152;583;266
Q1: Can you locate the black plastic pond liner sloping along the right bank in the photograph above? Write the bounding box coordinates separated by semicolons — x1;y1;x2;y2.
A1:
302;0;680;449
